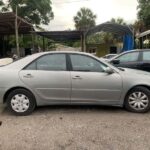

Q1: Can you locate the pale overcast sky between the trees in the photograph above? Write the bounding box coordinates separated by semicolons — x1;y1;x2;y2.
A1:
44;0;138;30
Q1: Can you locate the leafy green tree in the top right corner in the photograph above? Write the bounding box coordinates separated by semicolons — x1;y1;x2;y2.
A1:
137;0;150;28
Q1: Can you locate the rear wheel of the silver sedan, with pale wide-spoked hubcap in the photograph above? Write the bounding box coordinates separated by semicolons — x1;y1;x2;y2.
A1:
7;89;36;116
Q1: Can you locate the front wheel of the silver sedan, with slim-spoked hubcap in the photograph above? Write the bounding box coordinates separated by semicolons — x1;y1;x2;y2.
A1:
125;86;150;113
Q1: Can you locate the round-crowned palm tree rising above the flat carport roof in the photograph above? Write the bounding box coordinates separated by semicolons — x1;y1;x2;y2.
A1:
74;8;96;31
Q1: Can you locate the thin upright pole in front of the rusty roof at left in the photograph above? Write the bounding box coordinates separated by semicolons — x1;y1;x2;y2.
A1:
15;4;20;57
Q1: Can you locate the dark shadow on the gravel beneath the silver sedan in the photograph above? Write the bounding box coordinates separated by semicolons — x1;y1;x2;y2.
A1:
1;105;127;116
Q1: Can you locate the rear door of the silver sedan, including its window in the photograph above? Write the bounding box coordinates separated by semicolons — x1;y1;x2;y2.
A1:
20;54;71;102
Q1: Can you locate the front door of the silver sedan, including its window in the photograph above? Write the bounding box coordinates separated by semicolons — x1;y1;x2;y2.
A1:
70;54;122;104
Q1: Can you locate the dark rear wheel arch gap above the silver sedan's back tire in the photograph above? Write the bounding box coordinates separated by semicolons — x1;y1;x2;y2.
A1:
3;86;36;103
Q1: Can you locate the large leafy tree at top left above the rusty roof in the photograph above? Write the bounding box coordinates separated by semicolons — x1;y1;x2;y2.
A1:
2;0;54;25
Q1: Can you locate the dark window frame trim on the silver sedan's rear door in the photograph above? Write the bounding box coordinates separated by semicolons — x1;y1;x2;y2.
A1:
22;53;69;71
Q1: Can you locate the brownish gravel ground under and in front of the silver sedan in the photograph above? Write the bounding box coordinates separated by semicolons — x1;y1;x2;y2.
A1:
0;106;150;150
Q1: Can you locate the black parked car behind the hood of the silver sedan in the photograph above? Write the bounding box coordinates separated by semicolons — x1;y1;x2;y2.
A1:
109;49;150;72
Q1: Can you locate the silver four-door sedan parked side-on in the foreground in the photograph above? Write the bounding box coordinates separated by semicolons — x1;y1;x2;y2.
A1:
0;51;150;115
